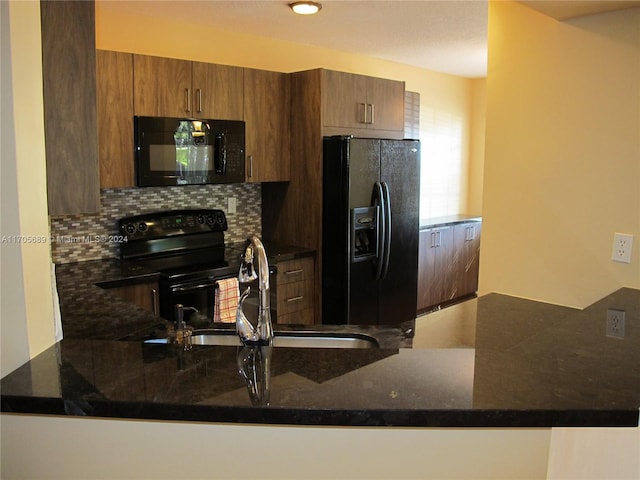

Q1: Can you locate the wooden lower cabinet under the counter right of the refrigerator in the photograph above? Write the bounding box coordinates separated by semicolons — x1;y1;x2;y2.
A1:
418;221;482;312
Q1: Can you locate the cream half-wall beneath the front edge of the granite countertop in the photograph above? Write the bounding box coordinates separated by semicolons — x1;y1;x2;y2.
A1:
2;415;551;480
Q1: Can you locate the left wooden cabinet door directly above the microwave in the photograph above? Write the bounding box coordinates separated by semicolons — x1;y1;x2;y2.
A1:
133;55;194;117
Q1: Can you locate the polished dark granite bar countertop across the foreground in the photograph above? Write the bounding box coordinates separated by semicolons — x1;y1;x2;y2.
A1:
1;262;640;427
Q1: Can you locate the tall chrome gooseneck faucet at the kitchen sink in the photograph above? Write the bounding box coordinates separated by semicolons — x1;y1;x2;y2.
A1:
236;235;273;345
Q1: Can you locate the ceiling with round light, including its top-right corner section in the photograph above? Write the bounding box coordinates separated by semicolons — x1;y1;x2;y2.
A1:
98;0;640;78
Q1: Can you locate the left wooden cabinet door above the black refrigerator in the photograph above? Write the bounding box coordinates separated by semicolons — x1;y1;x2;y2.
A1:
322;70;367;129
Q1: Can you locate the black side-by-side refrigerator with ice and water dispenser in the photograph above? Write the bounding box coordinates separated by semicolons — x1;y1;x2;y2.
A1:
322;136;420;325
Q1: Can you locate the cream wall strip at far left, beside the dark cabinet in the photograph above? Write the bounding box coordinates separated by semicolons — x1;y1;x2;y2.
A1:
0;1;55;376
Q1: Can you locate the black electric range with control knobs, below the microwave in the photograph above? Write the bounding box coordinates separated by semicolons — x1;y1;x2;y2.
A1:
118;209;242;325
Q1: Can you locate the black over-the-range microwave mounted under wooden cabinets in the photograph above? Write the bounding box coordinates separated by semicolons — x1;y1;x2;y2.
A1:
134;117;245;187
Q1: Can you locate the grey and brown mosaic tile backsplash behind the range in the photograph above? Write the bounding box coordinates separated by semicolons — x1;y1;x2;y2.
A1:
50;183;262;264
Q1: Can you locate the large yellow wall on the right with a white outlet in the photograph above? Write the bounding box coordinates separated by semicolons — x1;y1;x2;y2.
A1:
480;1;640;308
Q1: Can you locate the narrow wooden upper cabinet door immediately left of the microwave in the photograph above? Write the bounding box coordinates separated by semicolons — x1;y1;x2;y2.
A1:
96;50;135;188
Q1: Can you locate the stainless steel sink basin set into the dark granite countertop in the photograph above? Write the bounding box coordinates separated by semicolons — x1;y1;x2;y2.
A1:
145;329;379;348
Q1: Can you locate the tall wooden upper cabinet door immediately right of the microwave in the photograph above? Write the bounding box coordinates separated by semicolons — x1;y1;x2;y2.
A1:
244;68;290;182
